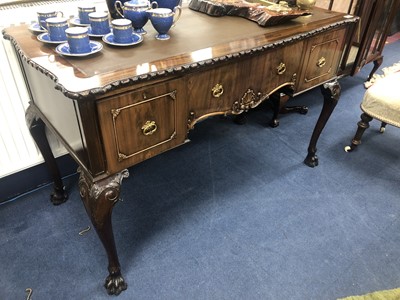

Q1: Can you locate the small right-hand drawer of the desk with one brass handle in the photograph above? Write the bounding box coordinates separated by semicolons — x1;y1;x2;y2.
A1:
296;28;346;91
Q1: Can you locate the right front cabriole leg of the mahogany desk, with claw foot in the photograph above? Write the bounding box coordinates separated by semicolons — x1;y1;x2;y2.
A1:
304;80;341;168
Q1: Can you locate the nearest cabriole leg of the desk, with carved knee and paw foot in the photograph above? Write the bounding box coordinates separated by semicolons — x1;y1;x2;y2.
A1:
78;168;129;295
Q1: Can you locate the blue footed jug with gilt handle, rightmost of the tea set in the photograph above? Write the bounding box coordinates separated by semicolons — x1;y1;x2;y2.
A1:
149;6;182;40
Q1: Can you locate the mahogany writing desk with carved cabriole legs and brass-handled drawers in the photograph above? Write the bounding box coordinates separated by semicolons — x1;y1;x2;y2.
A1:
3;8;357;294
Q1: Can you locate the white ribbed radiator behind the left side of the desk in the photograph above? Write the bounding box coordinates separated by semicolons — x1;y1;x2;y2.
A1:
0;0;107;178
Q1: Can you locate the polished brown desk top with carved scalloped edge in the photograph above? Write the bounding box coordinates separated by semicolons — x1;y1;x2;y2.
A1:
3;8;354;98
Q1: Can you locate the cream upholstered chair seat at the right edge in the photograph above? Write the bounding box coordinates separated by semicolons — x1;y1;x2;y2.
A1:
361;72;400;127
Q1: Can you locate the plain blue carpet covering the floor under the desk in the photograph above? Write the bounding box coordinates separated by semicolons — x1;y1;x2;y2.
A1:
0;42;400;300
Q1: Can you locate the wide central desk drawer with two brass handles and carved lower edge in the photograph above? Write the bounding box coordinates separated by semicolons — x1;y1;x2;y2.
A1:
187;41;303;127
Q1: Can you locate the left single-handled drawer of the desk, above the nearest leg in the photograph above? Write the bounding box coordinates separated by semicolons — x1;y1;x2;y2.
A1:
97;80;187;173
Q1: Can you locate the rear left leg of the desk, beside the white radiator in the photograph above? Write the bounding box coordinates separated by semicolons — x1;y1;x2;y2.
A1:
25;106;68;205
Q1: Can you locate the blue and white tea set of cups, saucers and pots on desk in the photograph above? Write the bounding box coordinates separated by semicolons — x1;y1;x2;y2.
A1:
29;0;182;57
